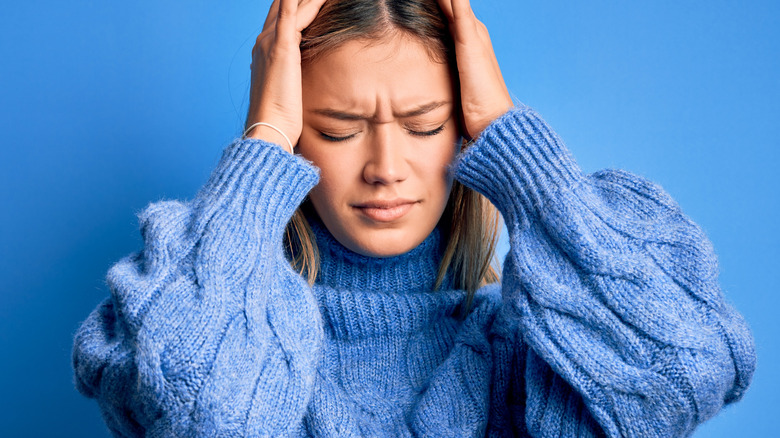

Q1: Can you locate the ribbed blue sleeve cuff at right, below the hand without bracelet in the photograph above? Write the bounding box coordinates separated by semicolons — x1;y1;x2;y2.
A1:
453;106;585;226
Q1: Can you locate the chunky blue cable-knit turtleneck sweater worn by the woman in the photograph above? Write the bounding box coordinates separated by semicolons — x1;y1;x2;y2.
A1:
73;107;755;437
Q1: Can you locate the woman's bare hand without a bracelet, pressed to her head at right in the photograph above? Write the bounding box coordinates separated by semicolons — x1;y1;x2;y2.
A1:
438;0;514;139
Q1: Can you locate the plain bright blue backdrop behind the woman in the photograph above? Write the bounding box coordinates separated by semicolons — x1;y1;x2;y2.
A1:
0;0;780;437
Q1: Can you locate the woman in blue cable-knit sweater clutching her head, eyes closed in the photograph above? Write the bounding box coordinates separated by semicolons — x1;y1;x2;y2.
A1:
73;0;755;437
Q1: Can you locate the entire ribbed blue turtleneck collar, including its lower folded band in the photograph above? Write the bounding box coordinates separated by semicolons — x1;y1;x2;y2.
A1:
309;212;466;339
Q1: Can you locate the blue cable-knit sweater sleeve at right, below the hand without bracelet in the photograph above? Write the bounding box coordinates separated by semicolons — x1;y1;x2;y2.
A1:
454;107;755;437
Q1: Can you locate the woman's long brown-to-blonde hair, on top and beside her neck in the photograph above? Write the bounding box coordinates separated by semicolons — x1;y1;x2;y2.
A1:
284;0;499;316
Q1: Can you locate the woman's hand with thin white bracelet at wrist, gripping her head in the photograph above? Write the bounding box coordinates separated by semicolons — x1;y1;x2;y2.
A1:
244;0;326;148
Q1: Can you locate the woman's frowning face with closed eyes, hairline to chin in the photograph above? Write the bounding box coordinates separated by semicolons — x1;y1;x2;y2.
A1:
296;36;460;257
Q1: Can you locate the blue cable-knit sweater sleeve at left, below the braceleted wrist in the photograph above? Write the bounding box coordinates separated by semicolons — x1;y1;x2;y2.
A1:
72;139;323;437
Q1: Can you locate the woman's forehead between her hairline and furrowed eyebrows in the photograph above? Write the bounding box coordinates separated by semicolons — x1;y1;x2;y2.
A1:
302;36;453;112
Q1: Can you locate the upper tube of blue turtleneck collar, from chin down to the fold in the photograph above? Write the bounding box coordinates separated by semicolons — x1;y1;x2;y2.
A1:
308;215;449;294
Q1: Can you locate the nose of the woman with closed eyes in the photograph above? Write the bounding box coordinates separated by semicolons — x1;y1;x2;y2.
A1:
363;124;410;185
